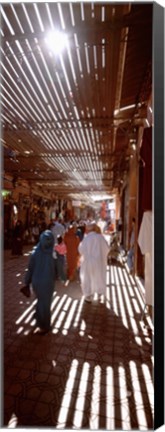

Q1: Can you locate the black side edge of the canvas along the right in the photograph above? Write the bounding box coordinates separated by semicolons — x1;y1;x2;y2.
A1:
153;3;164;430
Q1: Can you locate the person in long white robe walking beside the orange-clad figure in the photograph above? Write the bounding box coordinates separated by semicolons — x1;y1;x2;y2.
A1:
78;223;109;302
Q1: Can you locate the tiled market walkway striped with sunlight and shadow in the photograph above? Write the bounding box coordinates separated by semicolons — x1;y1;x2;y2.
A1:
3;246;154;430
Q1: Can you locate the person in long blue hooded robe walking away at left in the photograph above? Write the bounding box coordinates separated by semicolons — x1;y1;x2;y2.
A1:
25;230;55;334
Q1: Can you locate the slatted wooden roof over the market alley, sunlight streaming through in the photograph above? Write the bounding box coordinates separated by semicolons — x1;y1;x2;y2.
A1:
0;2;153;204
